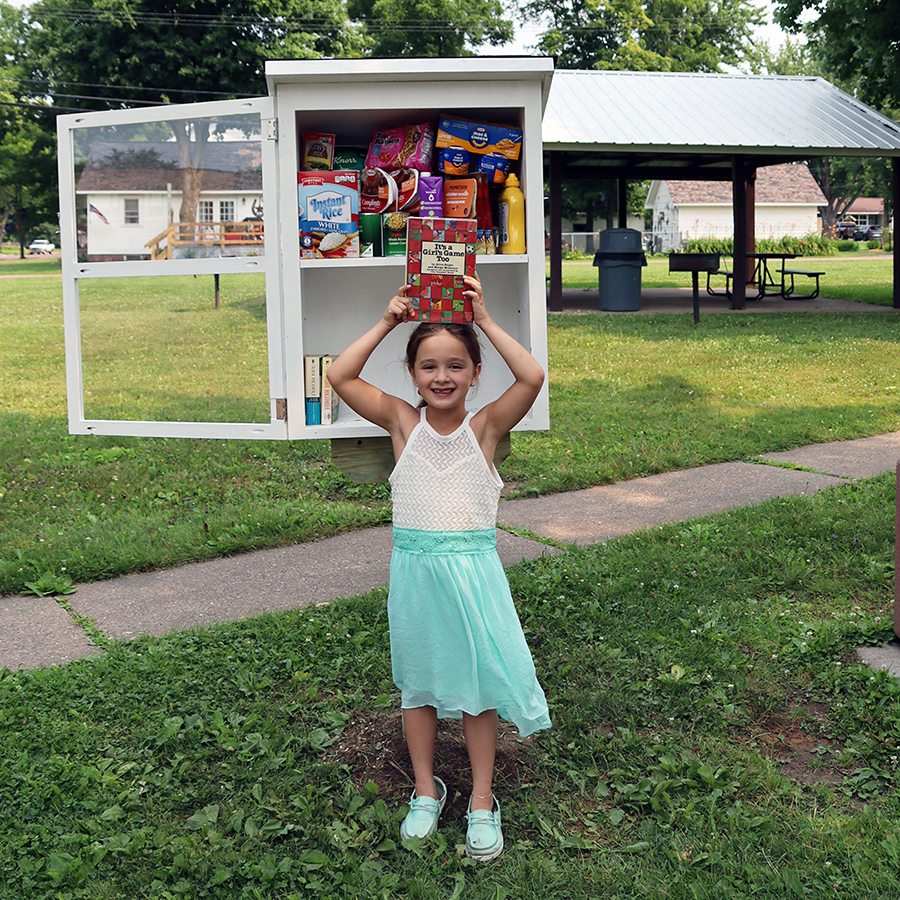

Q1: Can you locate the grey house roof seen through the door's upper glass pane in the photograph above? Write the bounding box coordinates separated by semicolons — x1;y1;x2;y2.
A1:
76;141;262;194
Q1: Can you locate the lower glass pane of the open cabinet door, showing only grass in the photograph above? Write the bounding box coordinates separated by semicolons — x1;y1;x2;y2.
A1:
78;275;271;423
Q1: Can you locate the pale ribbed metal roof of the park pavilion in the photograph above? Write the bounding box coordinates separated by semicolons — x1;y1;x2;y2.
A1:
543;69;900;178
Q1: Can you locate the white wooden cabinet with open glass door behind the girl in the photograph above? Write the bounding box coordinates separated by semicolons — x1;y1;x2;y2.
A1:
58;57;552;439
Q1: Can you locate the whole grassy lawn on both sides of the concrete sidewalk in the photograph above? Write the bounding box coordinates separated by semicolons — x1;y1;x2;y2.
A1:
0;256;900;900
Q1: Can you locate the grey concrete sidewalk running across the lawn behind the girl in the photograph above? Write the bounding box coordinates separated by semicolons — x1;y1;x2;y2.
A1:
0;432;900;675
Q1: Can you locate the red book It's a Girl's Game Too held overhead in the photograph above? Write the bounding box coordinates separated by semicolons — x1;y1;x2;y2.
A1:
406;216;478;322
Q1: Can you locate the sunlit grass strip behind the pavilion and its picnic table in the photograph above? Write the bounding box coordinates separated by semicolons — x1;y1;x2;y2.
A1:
563;251;893;306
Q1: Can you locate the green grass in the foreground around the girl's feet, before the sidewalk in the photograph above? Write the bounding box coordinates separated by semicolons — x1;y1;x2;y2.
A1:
0;476;900;900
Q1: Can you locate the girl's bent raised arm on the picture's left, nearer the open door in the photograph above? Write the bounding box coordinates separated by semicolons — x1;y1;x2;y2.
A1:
328;285;413;435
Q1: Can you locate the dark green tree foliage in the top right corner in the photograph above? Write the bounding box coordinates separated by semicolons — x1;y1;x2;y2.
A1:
775;0;900;110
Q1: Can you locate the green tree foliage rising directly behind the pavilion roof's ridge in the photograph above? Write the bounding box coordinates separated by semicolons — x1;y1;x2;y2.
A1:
522;0;762;72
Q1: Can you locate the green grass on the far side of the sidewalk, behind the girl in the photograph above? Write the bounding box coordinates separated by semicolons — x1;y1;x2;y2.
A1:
0;261;900;594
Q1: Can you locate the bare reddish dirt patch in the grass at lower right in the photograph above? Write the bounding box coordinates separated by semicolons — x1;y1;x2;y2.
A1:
752;701;844;787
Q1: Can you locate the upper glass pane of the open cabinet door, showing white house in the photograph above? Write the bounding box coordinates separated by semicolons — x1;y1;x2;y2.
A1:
74;114;265;262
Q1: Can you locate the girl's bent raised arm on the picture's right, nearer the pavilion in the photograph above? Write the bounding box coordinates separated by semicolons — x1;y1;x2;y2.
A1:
466;275;544;446
